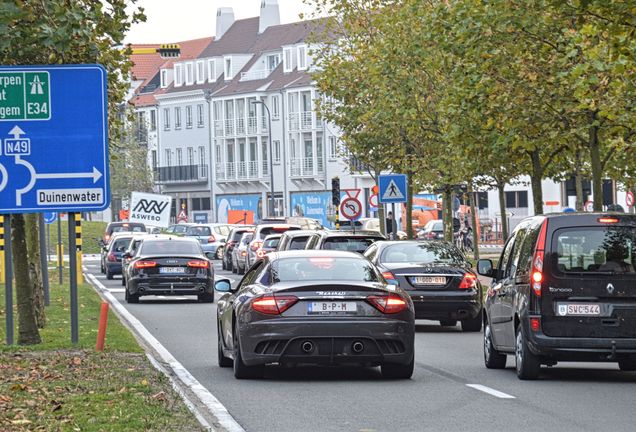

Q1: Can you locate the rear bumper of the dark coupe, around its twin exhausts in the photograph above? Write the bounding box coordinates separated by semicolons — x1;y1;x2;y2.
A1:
239;318;415;366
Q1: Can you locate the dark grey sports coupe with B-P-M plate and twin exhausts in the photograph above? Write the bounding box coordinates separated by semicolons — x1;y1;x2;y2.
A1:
216;250;415;379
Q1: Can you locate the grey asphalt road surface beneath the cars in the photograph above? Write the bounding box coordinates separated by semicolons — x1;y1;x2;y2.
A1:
85;261;636;432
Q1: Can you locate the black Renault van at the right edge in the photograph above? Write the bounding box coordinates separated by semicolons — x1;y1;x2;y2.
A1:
477;213;636;379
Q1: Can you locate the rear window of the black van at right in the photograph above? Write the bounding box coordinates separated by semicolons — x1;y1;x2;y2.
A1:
553;226;636;274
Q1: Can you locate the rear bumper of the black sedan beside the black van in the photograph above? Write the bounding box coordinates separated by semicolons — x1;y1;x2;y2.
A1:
407;289;482;320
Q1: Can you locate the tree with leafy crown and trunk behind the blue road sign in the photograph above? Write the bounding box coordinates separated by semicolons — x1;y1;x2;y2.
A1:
0;0;145;344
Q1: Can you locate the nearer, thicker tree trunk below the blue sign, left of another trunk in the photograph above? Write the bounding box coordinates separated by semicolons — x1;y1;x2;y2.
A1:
11;214;42;345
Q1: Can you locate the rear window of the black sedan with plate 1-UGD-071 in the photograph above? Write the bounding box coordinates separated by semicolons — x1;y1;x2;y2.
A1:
380;242;465;264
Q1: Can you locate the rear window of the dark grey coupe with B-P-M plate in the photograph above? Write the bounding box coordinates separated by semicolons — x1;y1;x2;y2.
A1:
271;257;379;282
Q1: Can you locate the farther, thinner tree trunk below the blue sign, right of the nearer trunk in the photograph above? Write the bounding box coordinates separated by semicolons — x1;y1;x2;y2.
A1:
24;214;46;328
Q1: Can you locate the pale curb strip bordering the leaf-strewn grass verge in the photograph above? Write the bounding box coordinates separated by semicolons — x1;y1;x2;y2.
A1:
84;273;245;432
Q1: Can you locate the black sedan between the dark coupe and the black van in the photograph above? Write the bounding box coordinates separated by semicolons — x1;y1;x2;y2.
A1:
364;240;483;332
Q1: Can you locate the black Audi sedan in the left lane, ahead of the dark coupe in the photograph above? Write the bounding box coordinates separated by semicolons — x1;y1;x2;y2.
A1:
125;236;214;303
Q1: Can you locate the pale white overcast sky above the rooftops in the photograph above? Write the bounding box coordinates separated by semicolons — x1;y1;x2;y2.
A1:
124;0;322;43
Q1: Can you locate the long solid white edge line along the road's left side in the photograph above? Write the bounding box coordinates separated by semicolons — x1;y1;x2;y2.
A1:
84;273;245;432
